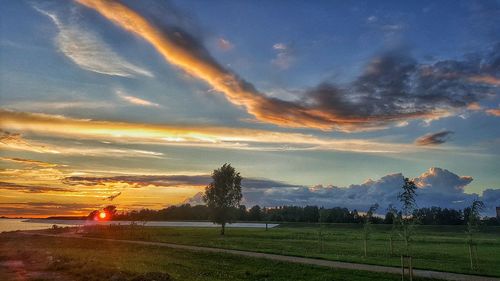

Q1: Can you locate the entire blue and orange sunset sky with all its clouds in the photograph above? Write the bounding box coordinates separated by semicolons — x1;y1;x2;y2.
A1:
0;0;500;217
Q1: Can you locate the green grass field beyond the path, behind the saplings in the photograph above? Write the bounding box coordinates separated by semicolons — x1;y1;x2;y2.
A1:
82;224;500;276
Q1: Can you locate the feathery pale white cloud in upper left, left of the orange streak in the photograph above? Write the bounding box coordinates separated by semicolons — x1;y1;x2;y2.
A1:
34;6;154;77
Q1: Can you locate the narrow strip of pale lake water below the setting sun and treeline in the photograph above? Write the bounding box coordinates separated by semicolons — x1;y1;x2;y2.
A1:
0;219;278;232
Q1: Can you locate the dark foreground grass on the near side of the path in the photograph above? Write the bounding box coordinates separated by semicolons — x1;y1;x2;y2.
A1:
0;232;438;281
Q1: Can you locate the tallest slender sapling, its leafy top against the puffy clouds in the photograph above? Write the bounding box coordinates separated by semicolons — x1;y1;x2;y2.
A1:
398;178;417;256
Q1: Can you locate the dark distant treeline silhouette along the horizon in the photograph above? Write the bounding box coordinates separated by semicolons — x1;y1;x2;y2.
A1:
107;204;498;225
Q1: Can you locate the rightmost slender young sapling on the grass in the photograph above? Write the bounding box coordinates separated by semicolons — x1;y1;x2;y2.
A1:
464;199;484;270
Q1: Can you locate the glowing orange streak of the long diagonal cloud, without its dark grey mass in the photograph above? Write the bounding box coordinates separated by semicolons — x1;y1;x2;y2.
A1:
77;0;446;131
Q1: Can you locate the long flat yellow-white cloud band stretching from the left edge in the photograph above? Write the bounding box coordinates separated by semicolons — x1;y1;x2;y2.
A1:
0;110;426;154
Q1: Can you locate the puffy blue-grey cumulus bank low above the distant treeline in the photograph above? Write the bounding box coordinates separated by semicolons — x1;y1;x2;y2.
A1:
186;168;500;215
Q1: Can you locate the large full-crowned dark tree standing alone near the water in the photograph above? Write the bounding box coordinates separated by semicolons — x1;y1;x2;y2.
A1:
203;163;242;235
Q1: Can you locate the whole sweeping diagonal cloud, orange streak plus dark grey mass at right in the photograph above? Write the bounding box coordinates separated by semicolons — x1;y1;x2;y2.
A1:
77;0;500;131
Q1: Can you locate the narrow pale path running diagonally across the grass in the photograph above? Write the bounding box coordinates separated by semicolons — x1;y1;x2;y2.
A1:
20;232;500;281
